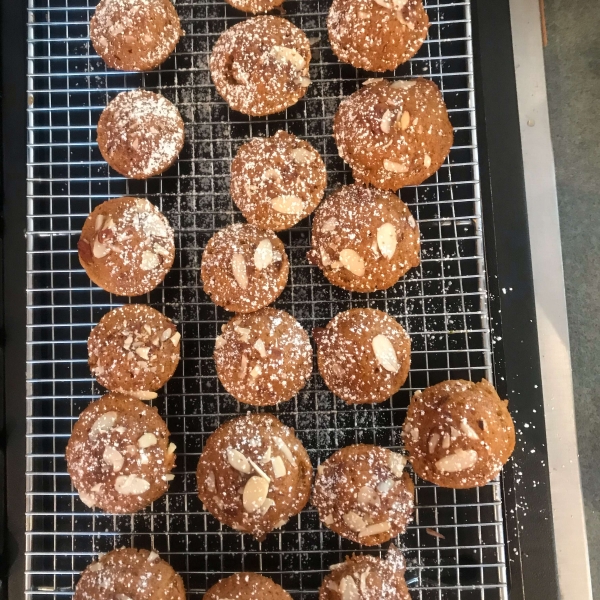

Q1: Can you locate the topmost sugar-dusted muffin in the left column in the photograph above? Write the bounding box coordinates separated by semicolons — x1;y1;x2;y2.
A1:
90;0;183;71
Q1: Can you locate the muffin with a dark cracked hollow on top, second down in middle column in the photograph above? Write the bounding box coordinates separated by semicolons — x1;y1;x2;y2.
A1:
209;16;310;116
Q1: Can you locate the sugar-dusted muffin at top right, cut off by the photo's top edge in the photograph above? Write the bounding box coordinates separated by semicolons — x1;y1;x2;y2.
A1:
327;0;429;71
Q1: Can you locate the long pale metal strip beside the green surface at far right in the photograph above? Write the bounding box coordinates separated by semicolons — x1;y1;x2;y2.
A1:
511;0;592;600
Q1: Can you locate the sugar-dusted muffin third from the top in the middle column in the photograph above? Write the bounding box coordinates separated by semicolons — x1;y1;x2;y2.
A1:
231;131;327;231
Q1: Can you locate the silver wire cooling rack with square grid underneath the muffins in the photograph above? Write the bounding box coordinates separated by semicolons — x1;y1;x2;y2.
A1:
26;0;507;600
